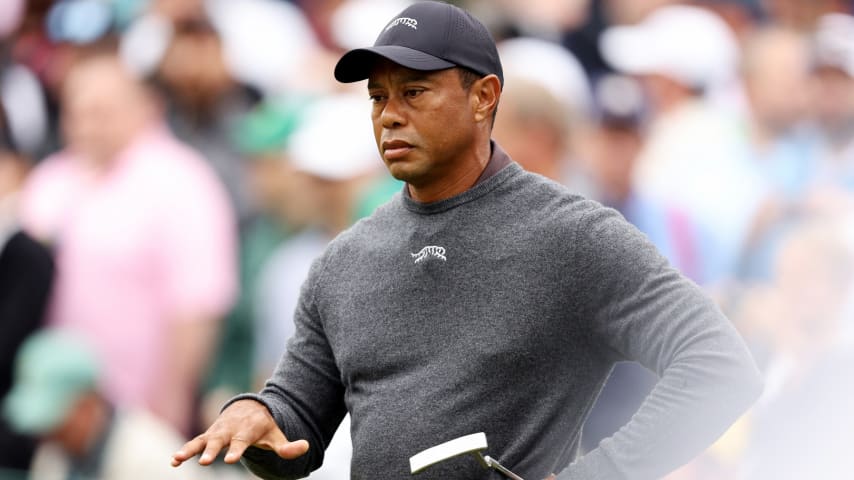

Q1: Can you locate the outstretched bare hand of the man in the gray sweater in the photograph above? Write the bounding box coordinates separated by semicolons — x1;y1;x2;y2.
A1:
172;399;308;467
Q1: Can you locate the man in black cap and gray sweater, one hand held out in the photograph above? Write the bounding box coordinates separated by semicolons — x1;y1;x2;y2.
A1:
173;2;759;480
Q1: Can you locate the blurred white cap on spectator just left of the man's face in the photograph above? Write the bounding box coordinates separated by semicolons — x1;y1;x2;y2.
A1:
288;94;383;181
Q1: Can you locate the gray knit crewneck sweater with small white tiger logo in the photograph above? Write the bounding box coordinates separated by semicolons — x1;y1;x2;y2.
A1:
232;148;760;480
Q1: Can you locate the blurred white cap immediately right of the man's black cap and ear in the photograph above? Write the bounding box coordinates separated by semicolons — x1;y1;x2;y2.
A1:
498;37;592;115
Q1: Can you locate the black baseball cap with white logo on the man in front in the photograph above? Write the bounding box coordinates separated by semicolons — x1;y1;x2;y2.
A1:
335;2;504;86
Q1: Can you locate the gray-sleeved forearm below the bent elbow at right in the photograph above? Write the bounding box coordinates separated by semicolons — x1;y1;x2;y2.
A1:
558;340;761;480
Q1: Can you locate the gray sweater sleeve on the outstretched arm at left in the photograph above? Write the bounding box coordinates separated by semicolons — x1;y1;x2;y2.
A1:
229;253;346;480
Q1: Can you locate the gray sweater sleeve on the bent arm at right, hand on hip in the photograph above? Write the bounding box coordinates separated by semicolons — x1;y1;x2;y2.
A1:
558;207;761;480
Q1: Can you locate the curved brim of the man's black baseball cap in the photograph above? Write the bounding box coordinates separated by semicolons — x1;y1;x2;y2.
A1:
335;45;456;83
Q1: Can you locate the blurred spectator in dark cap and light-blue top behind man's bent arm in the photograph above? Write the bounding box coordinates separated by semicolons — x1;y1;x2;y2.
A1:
582;75;703;450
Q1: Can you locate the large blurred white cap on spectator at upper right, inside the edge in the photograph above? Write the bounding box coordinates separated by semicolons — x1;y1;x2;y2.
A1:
600;5;739;87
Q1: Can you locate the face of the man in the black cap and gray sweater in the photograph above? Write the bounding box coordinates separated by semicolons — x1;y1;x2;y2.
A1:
368;61;480;188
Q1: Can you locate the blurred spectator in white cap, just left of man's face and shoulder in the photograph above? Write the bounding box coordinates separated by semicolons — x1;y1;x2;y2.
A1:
257;94;388;480
